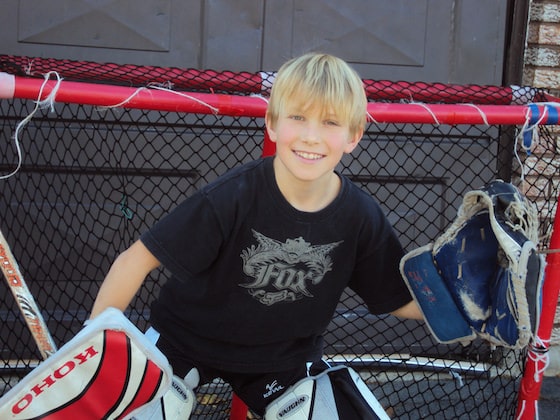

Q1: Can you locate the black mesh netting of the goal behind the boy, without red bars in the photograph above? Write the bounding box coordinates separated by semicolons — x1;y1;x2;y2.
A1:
0;56;558;419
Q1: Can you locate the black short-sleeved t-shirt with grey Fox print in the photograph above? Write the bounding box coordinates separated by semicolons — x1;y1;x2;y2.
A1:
141;158;411;372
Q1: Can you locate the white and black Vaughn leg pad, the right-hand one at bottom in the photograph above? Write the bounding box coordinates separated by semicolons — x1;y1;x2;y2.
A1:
264;366;389;420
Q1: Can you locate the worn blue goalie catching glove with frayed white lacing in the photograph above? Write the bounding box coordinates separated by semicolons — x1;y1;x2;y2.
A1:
400;180;544;348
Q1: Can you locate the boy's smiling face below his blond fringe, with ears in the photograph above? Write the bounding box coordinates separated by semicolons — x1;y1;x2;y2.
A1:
266;104;363;181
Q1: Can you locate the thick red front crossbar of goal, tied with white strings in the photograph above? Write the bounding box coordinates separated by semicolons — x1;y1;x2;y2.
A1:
0;73;560;125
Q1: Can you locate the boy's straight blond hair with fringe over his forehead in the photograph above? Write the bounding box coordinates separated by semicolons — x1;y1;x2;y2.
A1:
267;53;367;134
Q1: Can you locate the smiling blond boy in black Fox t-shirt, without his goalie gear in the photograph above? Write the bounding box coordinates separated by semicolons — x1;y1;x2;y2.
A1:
92;53;421;415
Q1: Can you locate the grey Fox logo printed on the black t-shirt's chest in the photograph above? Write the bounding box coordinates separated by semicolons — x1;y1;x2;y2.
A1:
240;231;342;306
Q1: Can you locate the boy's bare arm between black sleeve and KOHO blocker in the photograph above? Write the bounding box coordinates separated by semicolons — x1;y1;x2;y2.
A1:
90;240;160;318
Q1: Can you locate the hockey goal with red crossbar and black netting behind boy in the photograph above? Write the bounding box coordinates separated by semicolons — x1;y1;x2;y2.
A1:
0;56;560;419
